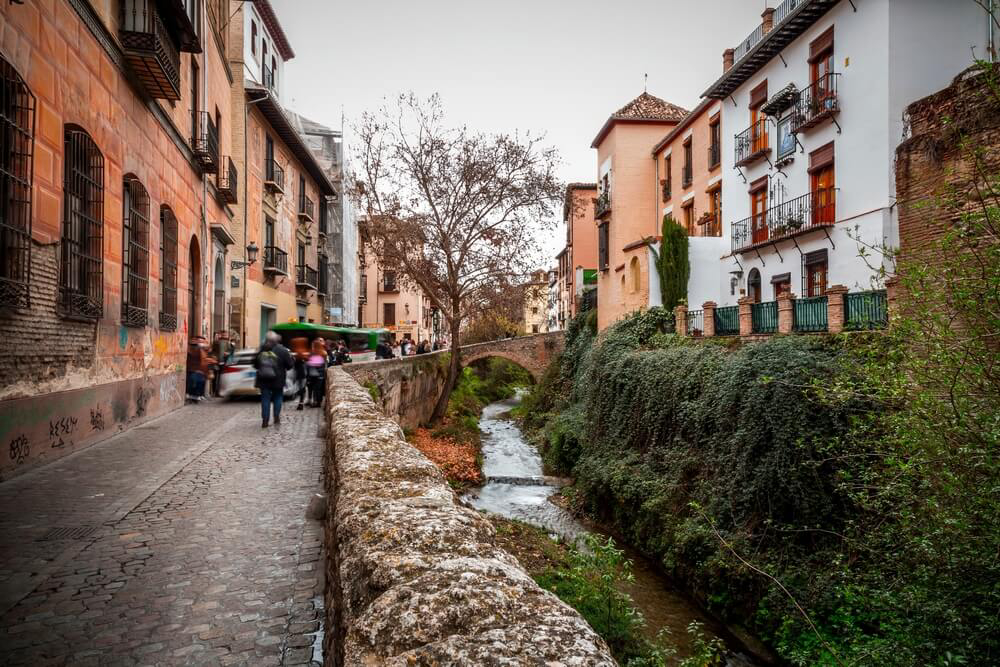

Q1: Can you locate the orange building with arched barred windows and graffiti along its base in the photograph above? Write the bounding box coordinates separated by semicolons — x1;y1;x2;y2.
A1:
0;0;238;477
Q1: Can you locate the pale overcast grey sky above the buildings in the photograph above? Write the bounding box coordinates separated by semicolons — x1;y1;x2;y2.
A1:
271;0;778;255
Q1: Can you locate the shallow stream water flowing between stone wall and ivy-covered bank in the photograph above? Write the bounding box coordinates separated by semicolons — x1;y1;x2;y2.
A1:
464;398;758;667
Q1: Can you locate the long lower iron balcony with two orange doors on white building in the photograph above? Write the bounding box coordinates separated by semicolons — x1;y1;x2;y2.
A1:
732;188;838;252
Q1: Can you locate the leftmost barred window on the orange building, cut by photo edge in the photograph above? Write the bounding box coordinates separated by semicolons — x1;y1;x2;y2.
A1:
0;58;35;308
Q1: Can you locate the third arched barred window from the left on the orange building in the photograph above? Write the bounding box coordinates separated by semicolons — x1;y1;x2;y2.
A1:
122;175;149;327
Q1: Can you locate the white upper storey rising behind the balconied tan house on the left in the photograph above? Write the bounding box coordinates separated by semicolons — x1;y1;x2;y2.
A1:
243;0;295;102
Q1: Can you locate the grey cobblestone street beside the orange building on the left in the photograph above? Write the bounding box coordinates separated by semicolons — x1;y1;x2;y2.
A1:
0;400;323;665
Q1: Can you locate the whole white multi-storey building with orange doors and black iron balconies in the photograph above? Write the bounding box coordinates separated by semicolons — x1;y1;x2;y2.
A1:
692;0;993;307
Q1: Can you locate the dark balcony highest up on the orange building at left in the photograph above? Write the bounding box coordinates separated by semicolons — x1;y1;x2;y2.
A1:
118;0;181;101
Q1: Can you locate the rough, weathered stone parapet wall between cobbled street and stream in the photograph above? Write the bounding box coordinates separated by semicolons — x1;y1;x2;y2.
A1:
324;368;615;667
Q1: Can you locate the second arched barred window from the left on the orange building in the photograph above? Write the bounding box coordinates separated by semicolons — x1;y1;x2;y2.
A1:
59;125;104;319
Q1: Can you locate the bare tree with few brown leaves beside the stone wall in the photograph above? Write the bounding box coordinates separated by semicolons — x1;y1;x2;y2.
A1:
355;93;562;418
